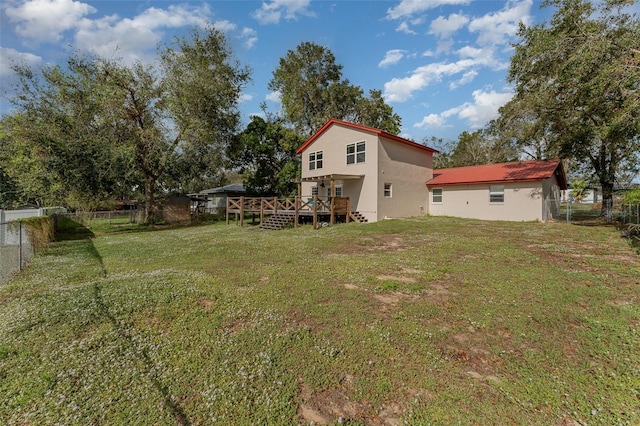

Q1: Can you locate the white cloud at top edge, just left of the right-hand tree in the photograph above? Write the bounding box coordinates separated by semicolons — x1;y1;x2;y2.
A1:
469;0;533;46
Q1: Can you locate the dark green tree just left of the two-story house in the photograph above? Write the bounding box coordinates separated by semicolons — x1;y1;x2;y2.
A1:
228;115;304;197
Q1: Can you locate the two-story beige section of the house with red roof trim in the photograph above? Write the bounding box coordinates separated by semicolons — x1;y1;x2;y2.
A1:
296;119;438;222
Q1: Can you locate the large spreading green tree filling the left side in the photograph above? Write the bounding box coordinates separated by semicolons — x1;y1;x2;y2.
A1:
0;28;249;221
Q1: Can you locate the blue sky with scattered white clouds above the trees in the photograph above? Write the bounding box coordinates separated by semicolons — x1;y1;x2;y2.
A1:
0;0;553;142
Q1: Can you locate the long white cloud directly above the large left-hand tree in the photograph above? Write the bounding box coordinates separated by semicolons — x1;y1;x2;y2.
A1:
75;4;211;63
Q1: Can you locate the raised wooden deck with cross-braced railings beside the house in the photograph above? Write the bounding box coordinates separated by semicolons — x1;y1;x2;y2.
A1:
227;196;359;229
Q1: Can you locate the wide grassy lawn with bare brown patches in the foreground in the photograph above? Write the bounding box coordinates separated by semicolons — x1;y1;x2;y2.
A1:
0;218;640;425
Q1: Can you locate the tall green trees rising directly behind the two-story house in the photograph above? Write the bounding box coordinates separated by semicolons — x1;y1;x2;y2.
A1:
269;42;401;136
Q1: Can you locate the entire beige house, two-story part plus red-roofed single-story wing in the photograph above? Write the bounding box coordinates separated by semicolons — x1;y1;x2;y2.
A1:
297;119;567;222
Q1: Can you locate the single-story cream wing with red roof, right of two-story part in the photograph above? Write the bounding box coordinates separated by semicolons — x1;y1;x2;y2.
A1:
427;160;567;221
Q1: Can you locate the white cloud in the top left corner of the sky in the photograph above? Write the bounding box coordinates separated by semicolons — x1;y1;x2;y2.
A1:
3;0;96;42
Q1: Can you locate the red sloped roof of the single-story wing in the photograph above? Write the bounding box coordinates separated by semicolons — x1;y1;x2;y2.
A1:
427;159;567;189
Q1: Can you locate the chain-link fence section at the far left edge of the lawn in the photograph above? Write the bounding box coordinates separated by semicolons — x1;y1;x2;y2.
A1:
0;222;34;284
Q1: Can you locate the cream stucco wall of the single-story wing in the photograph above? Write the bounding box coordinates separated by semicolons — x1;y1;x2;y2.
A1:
429;180;557;221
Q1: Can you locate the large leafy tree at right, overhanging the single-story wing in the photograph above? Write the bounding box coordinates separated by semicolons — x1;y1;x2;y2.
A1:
499;0;640;206
